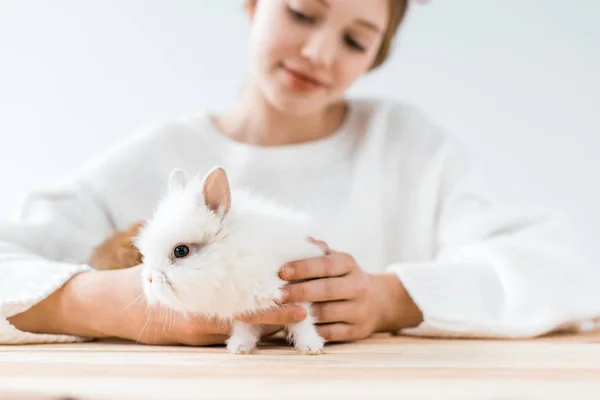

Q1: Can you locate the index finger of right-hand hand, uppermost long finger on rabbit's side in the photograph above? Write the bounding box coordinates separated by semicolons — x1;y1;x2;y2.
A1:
279;253;355;281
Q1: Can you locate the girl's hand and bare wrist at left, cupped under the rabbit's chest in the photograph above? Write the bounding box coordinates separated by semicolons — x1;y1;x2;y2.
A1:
9;266;306;346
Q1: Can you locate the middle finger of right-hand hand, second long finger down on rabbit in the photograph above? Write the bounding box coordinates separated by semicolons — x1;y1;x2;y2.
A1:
283;276;356;303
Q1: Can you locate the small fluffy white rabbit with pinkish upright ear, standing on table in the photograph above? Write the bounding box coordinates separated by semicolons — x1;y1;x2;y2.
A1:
134;167;324;354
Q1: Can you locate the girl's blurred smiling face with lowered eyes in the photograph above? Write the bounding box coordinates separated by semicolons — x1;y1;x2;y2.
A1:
250;0;389;115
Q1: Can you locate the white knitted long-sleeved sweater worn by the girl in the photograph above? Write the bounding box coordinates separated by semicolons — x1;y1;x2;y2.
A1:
0;99;600;344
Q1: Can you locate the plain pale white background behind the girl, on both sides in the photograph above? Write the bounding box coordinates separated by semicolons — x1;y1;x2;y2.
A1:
0;0;600;265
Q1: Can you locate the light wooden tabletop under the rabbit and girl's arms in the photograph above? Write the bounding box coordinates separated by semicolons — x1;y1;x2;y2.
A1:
0;332;600;400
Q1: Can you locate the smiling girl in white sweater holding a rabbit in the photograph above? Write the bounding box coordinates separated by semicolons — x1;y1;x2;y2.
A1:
0;0;600;345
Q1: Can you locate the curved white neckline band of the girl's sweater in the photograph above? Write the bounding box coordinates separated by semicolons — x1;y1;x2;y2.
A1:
198;100;358;167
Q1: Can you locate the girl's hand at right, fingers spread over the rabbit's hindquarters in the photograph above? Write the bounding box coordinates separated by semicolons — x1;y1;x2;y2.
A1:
280;242;422;342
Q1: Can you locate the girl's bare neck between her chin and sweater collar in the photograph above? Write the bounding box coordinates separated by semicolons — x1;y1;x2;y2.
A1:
216;79;346;146
